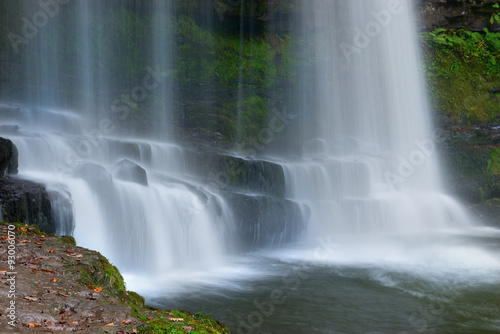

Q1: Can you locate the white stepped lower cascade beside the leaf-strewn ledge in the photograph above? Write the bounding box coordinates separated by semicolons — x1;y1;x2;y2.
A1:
0;107;232;275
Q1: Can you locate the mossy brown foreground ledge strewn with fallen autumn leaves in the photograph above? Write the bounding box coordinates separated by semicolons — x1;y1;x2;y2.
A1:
0;222;229;334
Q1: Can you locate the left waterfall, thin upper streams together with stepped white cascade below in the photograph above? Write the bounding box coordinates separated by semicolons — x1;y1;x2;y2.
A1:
0;0;233;275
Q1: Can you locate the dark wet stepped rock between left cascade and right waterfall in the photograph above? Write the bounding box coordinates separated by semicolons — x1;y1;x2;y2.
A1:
183;149;309;250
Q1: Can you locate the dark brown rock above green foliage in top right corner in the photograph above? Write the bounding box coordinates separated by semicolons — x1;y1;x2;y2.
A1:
419;0;500;31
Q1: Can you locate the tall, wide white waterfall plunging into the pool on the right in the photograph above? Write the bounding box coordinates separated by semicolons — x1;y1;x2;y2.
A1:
284;0;469;240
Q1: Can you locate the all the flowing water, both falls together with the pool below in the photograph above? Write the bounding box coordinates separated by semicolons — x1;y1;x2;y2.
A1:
0;0;500;334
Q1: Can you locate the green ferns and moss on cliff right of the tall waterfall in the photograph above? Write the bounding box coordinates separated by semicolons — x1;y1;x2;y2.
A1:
421;29;500;124
